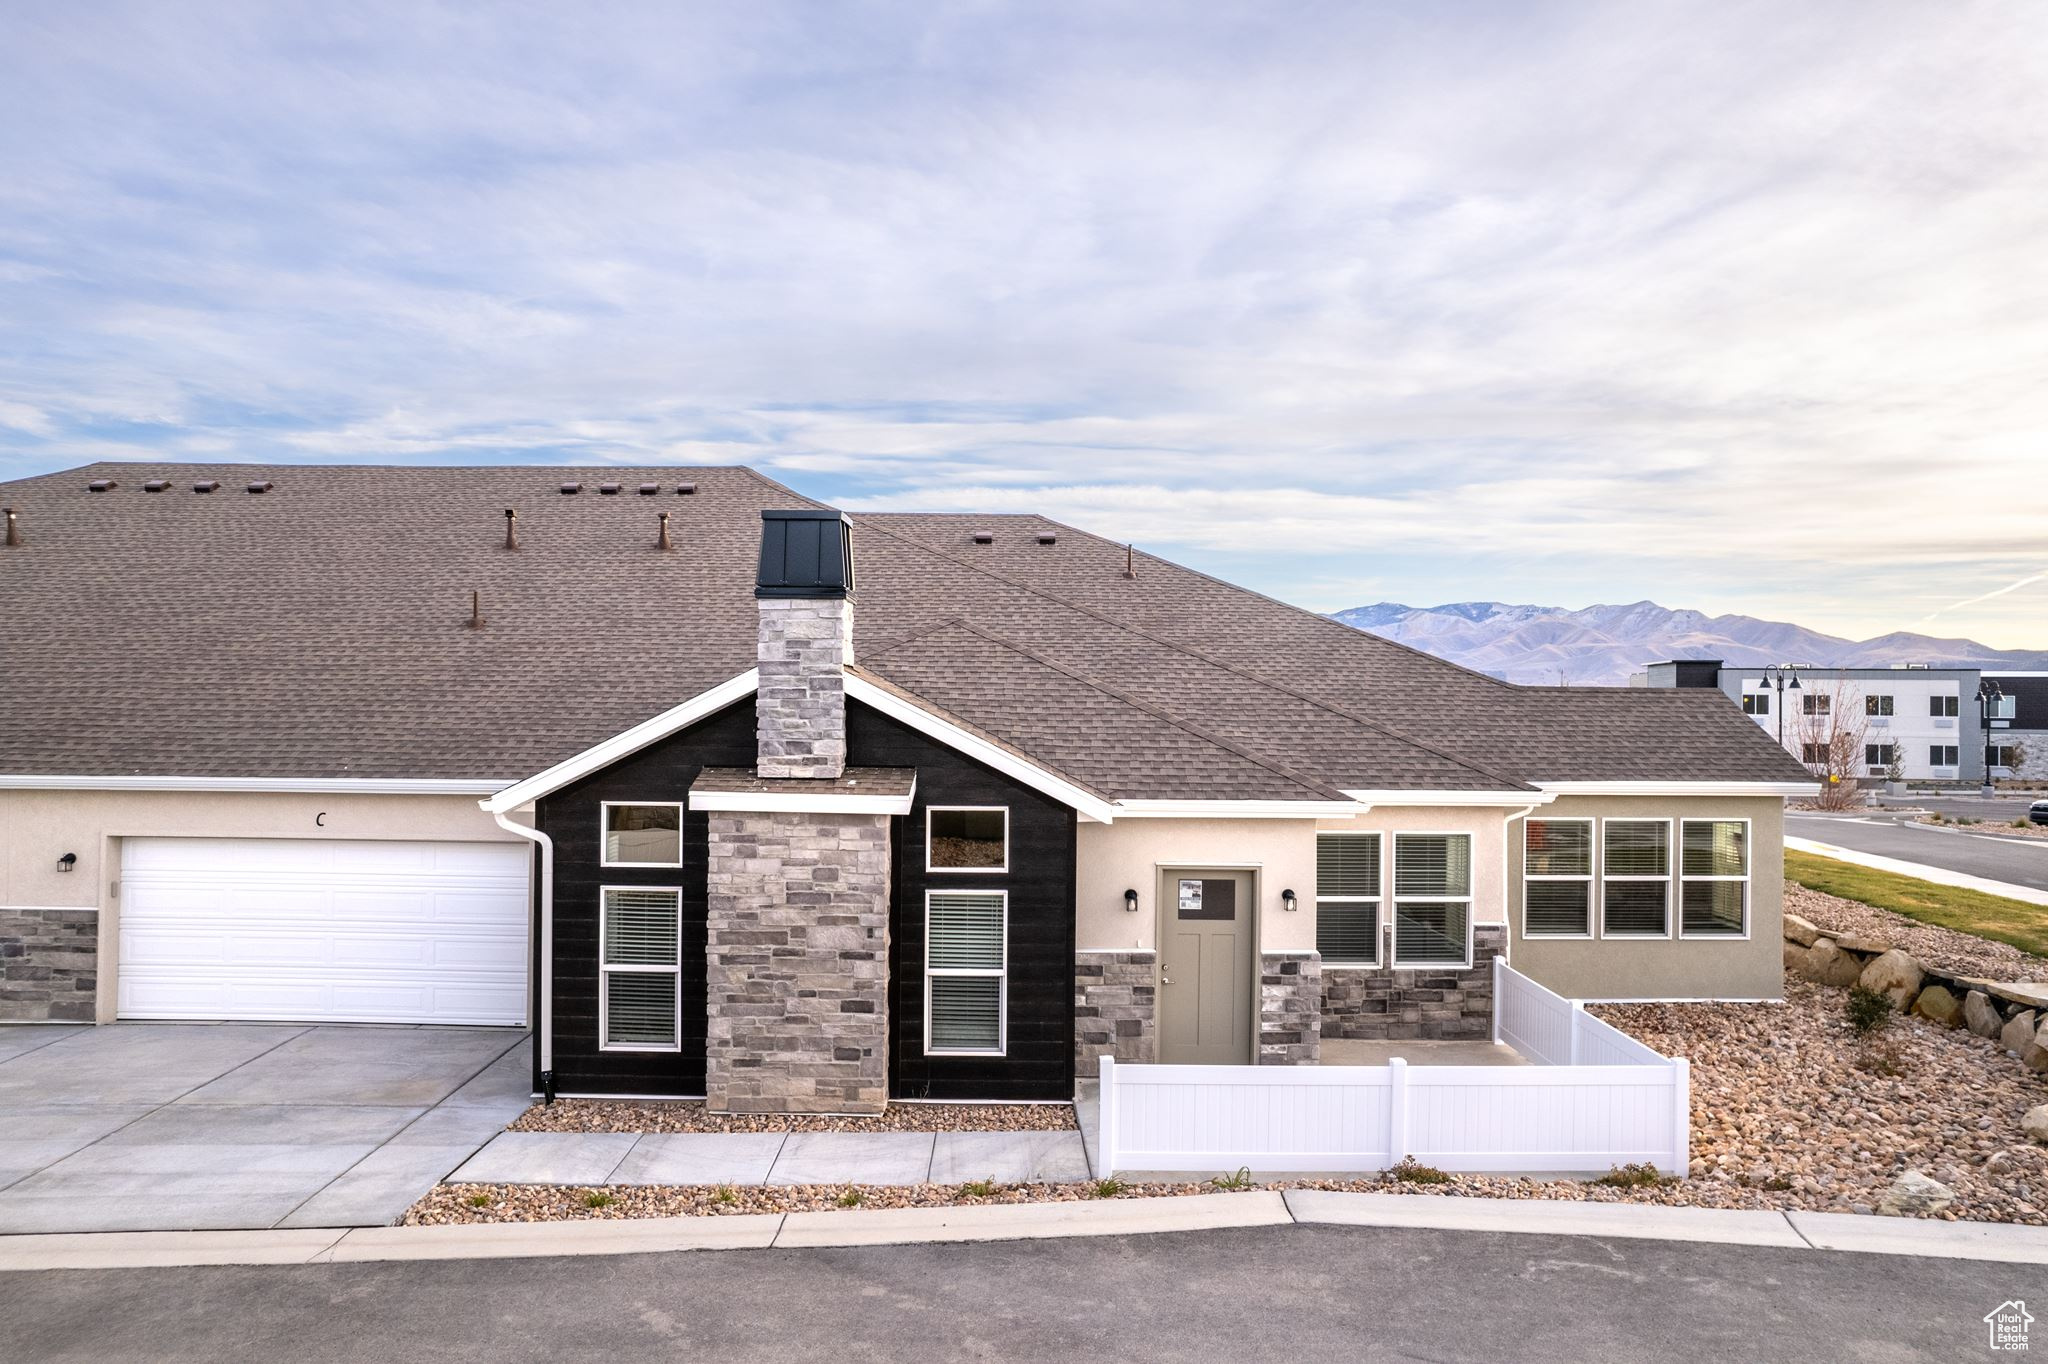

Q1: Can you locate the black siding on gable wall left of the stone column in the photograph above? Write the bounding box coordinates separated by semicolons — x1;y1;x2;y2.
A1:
537;700;754;1096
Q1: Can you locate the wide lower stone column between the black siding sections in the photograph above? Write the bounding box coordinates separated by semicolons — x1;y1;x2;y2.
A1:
705;802;889;1114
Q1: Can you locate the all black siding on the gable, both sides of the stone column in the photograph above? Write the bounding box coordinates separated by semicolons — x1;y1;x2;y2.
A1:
535;702;1075;1100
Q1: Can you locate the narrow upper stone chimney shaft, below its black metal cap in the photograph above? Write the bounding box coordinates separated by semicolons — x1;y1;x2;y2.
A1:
754;596;854;776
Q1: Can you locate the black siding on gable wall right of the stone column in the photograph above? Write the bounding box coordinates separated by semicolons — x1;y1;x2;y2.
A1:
846;702;1075;1100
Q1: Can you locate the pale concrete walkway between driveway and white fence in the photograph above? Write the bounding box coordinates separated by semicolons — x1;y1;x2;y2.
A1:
446;1131;1090;1186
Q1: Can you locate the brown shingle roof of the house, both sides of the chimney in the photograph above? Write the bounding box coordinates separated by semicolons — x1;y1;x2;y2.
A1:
0;465;1810;801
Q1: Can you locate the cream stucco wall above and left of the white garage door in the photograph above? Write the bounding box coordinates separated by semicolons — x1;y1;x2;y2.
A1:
0;791;516;1022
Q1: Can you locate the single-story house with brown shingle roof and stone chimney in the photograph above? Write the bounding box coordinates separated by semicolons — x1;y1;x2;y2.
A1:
0;465;1812;1112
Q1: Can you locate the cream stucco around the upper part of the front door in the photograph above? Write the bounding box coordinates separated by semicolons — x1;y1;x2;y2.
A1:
1075;819;1315;952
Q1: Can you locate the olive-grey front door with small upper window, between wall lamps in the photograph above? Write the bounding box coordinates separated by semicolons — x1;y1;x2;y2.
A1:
1159;868;1257;1065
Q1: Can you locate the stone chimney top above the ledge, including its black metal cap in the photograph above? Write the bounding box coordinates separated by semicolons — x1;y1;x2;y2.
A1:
754;510;854;780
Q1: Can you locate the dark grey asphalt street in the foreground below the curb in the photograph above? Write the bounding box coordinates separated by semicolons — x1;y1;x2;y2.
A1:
0;1227;2048;1364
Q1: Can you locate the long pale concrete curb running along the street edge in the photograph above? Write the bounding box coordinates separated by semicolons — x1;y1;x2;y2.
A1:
0;1188;2048;1272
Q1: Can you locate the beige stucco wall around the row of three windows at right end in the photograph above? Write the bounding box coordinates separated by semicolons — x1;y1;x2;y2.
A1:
1507;797;1784;999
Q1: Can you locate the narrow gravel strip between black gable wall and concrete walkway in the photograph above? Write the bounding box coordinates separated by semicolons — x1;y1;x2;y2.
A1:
506;1100;1073;1133
